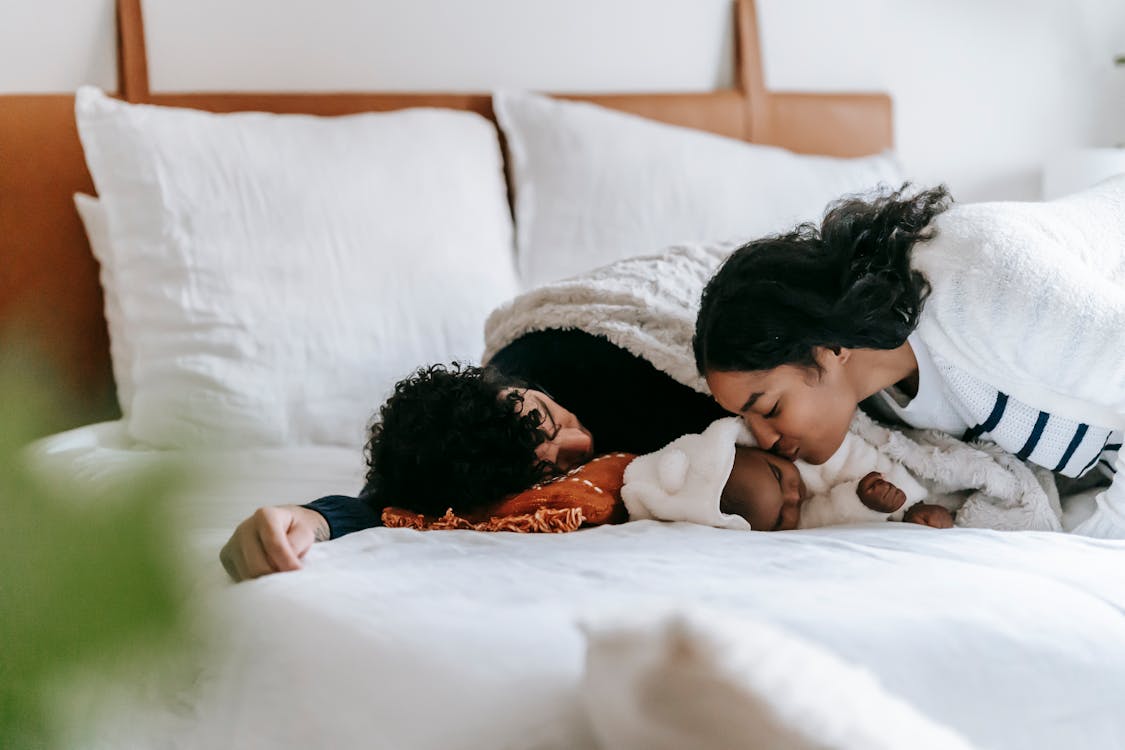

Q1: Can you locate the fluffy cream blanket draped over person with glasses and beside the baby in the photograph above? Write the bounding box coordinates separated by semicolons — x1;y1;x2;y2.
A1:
485;243;1062;531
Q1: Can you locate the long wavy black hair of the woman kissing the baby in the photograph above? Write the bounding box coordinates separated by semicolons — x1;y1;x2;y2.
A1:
693;183;952;373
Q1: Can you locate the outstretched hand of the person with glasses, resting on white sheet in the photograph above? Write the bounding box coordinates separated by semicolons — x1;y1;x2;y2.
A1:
218;505;329;580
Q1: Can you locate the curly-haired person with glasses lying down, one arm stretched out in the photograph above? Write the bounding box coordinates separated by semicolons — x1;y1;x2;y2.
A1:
221;329;727;580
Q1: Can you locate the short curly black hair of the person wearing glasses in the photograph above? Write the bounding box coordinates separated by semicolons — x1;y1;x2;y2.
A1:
361;362;555;515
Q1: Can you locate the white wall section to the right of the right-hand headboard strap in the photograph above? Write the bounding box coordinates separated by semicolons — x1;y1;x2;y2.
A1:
761;0;1125;200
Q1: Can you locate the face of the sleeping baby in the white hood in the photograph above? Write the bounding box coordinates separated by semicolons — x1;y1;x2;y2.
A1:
720;446;809;531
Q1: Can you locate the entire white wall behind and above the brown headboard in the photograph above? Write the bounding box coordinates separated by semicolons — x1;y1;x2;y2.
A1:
0;0;1125;200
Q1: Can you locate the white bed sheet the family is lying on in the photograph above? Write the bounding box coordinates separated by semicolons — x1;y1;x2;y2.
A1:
30;425;1125;750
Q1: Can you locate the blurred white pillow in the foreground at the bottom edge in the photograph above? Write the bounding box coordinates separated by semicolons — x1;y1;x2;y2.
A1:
582;609;971;750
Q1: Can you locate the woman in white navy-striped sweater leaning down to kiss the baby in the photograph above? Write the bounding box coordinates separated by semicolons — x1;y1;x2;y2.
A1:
693;187;1125;537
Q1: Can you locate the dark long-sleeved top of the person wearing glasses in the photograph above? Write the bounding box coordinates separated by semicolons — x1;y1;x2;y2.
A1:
305;329;729;539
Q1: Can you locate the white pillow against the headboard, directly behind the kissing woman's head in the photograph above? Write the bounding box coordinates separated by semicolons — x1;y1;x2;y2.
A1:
493;92;902;287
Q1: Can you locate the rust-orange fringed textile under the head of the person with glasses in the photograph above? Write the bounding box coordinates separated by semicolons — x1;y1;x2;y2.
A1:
383;453;637;533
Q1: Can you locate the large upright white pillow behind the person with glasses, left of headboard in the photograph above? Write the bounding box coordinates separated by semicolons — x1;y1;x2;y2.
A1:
77;88;518;446
